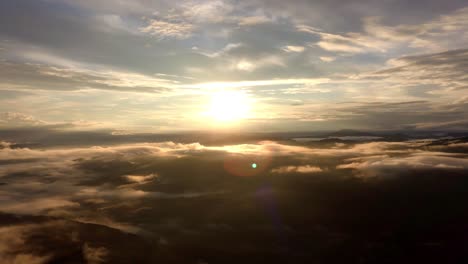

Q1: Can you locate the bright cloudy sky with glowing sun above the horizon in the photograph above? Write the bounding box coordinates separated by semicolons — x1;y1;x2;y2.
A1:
0;0;468;133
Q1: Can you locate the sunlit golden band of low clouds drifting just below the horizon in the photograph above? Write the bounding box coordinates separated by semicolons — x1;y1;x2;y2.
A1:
0;137;458;189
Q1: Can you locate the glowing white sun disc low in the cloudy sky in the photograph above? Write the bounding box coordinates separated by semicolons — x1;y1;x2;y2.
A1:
208;91;250;122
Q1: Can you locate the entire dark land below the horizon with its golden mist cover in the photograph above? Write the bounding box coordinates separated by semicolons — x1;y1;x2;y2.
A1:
0;130;468;263
